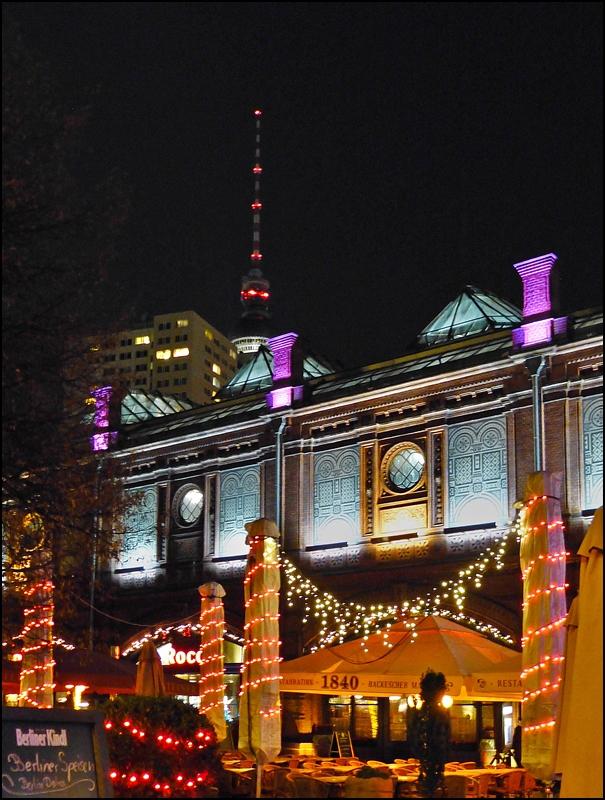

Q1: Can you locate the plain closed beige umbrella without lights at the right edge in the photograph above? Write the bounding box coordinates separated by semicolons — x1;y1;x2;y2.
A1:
552;507;603;797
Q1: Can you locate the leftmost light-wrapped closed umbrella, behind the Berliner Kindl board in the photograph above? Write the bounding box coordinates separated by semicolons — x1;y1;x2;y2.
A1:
18;514;55;708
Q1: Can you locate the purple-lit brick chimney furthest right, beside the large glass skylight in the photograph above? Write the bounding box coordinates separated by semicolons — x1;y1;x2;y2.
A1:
513;253;567;348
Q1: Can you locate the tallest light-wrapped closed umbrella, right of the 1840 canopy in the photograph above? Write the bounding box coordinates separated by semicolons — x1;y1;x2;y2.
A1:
520;472;567;780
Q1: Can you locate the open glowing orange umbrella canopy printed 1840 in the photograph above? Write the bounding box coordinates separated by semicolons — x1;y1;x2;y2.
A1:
280;616;522;701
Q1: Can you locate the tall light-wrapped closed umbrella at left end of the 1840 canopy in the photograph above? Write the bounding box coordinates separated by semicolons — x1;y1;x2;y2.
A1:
238;519;281;776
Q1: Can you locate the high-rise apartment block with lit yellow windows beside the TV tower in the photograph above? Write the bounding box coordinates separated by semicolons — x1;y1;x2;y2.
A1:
100;311;237;404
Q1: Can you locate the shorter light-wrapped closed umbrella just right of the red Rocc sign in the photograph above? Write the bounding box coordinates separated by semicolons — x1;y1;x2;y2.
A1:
198;581;227;742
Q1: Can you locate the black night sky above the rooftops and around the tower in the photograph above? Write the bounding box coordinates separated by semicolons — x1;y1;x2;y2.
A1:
4;2;602;366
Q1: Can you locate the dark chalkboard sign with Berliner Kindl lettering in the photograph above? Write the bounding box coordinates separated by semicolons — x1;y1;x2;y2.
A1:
2;707;113;798
